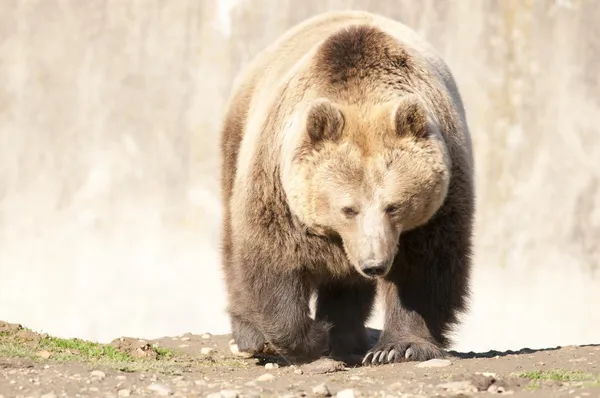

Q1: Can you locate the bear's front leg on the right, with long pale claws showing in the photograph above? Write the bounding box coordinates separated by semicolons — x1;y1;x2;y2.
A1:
363;207;471;364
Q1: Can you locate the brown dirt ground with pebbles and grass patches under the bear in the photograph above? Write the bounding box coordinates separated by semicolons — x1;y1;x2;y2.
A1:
0;322;600;398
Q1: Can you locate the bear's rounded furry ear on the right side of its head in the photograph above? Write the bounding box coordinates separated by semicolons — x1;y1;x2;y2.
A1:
392;94;427;138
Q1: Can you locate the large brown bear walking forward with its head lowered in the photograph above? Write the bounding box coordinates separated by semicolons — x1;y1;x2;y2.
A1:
221;11;474;364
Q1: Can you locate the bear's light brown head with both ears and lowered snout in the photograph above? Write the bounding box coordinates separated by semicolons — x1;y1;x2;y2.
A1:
282;94;450;277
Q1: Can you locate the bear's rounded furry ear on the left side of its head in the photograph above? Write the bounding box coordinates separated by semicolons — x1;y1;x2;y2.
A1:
306;98;344;144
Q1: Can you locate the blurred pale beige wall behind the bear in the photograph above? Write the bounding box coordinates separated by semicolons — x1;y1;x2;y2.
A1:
0;0;600;350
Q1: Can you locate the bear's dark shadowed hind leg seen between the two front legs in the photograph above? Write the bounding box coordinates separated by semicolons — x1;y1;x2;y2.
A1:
315;278;376;363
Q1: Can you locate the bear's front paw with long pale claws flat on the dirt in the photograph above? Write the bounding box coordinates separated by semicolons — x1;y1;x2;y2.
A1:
362;340;445;365
